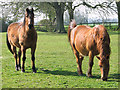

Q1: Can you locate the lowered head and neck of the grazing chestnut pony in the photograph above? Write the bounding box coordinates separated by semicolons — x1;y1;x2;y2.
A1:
96;25;111;81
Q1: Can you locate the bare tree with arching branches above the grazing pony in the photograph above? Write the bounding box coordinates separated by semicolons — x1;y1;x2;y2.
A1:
67;0;116;23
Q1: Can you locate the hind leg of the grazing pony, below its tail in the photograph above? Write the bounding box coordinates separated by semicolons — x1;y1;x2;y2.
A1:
74;50;83;75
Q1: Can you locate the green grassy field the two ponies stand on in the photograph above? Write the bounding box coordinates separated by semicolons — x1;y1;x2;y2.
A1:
0;31;120;88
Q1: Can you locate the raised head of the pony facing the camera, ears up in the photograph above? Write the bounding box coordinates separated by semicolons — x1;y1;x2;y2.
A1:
24;8;34;29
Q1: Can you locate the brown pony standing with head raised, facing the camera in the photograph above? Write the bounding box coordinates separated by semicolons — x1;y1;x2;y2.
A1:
7;8;37;73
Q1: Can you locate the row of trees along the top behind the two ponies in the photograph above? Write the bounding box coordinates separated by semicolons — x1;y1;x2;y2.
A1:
1;0;120;33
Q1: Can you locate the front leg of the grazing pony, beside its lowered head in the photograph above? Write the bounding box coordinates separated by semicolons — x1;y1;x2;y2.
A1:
87;51;94;77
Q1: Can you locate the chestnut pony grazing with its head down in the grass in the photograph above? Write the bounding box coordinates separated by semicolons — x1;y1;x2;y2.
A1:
68;20;111;81
